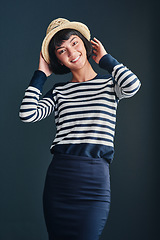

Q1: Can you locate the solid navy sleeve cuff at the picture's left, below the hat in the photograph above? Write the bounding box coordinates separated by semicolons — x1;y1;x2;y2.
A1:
29;70;47;92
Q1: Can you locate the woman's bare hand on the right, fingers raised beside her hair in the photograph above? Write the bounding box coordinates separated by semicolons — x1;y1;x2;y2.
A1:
91;37;107;64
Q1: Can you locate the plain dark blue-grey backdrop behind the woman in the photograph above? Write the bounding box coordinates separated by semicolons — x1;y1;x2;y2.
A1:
0;0;160;240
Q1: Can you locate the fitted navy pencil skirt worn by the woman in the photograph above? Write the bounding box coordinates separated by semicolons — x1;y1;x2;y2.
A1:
43;154;110;240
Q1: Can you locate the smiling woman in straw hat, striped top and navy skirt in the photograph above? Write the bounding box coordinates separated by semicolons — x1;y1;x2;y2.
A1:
20;18;140;240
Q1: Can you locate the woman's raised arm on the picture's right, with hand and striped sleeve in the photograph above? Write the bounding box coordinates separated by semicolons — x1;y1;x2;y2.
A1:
91;38;141;99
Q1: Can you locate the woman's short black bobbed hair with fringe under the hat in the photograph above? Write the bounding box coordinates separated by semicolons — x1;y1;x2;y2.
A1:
48;29;92;74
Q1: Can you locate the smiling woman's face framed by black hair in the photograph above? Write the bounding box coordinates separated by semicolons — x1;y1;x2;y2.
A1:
55;35;88;72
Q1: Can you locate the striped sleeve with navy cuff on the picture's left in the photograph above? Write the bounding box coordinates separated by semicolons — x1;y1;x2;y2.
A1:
19;70;55;122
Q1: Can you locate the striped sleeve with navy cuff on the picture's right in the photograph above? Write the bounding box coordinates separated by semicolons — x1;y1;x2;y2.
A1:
99;54;141;99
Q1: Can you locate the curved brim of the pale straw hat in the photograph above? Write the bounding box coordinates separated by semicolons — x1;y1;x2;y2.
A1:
41;22;91;64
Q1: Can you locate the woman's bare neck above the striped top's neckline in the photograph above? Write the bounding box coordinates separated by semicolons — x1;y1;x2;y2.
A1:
71;62;97;82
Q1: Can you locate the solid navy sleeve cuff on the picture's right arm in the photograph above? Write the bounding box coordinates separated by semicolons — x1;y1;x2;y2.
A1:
99;54;120;74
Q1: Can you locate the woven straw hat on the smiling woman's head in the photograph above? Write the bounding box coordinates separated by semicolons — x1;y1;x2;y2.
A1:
42;18;90;64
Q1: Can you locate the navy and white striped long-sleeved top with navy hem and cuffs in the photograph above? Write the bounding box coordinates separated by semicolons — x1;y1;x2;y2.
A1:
20;54;140;162
